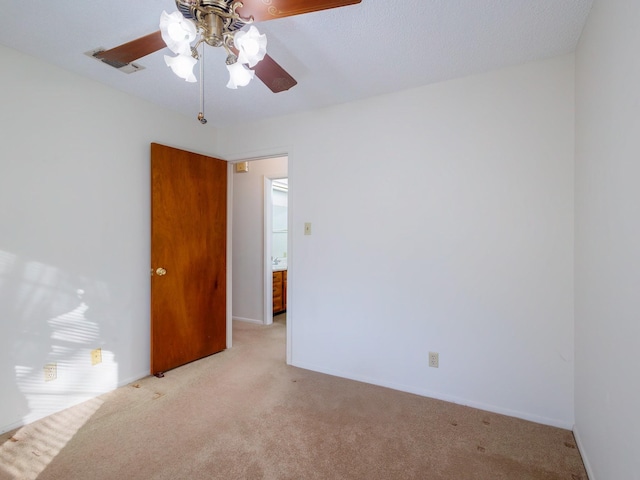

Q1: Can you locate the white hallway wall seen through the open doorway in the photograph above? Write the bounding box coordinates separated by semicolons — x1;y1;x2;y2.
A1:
232;157;287;323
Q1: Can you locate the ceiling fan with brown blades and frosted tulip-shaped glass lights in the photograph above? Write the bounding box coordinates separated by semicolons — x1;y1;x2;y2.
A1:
92;0;362;123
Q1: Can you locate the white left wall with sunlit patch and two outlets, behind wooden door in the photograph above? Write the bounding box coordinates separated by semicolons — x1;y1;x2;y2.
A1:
0;47;220;431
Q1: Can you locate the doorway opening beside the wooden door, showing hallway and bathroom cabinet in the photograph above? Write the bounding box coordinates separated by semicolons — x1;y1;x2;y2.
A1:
229;155;292;362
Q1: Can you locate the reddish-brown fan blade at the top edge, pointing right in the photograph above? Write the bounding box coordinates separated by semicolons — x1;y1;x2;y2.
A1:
237;0;362;22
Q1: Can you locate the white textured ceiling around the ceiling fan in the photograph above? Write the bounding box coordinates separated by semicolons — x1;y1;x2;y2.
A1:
0;0;593;126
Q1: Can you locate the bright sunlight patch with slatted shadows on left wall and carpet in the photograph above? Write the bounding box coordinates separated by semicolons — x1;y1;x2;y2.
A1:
0;250;118;479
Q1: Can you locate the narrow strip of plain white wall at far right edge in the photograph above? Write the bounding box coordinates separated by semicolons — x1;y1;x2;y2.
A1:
575;0;640;480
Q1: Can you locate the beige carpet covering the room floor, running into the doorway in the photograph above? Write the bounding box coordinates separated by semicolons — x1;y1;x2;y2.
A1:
0;321;587;480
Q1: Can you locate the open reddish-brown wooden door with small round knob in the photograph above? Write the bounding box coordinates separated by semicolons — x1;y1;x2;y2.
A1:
151;143;227;374
